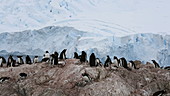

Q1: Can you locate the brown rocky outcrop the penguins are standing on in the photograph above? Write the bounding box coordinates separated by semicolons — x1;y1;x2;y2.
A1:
0;59;170;96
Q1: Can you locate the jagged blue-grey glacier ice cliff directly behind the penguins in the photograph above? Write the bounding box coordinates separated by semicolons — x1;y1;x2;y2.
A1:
0;26;170;66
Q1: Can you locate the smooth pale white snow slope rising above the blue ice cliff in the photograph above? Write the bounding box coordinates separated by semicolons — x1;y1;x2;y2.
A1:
0;0;170;36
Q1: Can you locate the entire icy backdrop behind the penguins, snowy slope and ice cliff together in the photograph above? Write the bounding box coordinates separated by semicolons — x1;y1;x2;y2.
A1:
0;0;170;65
